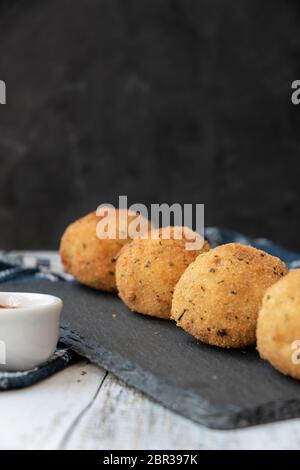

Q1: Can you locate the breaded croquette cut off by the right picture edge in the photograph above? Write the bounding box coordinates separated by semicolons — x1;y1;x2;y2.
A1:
257;269;300;380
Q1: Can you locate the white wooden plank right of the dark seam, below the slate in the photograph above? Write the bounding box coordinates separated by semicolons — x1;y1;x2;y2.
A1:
65;374;300;450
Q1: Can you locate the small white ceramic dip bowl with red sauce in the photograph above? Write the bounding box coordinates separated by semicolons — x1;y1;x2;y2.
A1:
0;292;63;371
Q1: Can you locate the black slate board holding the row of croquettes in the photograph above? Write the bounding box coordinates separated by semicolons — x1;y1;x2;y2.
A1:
1;280;300;429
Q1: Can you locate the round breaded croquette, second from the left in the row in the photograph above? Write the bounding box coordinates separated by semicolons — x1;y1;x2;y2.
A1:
116;227;210;319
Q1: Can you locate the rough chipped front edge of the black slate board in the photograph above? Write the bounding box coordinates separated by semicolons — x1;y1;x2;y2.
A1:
61;325;300;430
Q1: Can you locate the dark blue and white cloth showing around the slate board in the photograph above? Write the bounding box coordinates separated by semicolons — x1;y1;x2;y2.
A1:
0;227;300;390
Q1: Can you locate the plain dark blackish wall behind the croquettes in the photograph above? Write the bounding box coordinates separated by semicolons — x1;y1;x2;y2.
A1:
0;0;300;250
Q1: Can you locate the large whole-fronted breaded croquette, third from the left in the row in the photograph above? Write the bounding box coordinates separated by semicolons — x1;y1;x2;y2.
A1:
172;243;287;348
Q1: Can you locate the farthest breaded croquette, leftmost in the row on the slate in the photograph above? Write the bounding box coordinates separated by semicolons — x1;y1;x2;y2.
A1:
60;208;151;292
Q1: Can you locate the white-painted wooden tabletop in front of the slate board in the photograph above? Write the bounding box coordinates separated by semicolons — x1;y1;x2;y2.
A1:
0;252;300;450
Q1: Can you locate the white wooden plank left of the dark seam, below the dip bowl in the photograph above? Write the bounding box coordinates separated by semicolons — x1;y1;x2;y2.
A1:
0;362;105;449
